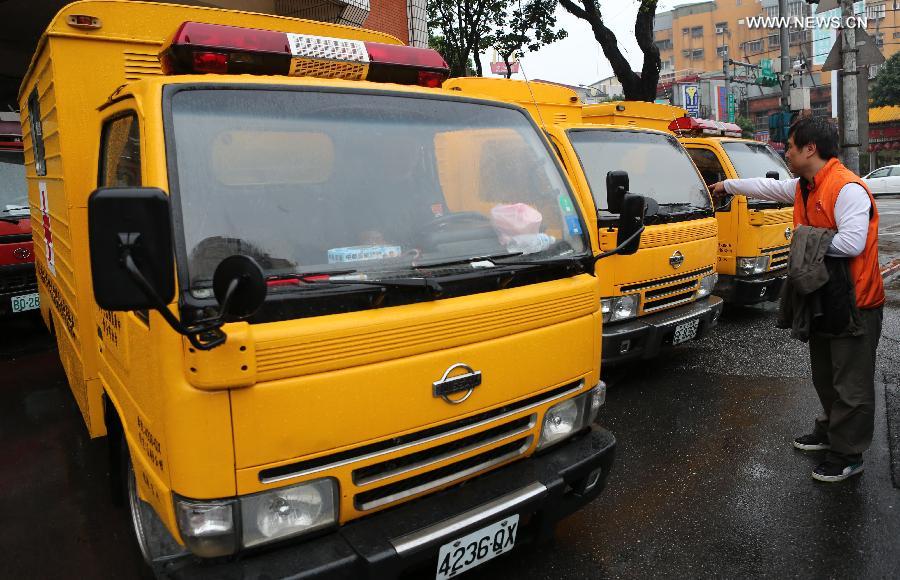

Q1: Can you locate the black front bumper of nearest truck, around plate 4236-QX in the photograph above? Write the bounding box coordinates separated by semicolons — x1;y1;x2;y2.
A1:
158;427;616;579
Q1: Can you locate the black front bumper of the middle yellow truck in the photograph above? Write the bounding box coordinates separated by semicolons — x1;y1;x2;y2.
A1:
602;296;722;365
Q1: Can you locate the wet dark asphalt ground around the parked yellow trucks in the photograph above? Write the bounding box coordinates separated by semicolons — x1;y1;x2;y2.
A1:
0;223;900;580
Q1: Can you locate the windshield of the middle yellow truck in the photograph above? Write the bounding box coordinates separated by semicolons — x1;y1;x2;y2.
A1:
568;129;711;215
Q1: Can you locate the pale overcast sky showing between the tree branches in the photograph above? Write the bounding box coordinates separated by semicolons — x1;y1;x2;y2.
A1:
481;0;698;85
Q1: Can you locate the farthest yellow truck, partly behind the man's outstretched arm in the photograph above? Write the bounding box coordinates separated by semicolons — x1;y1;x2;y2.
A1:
669;116;794;305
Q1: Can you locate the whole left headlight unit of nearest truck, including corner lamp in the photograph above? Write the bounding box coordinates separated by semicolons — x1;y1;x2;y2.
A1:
175;478;337;558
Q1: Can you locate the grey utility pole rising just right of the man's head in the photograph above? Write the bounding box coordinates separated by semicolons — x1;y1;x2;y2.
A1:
836;0;859;175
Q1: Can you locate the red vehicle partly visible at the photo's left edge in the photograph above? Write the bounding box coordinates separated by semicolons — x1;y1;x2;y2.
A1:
0;120;40;316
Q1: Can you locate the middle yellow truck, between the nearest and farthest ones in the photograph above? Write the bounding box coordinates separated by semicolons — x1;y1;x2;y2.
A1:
444;78;722;365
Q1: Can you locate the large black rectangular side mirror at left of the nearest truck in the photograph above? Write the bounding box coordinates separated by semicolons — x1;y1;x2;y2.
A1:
88;187;175;311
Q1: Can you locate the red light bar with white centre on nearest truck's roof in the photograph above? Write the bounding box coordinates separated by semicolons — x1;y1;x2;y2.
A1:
160;22;450;87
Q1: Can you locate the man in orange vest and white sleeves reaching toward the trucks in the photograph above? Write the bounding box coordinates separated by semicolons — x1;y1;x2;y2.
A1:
710;117;884;482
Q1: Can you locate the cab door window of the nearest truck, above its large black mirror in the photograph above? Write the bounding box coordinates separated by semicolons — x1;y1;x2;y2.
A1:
97;113;141;187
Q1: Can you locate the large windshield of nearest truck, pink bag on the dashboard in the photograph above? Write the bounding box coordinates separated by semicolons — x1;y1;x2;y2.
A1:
170;89;590;294
